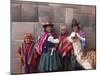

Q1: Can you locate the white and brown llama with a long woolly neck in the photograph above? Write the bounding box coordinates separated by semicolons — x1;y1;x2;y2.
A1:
67;32;96;69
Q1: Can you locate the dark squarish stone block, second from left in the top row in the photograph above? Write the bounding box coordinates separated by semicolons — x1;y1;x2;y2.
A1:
21;3;38;22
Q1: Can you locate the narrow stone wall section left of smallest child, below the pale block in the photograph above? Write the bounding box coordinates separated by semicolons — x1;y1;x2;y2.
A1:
11;40;22;73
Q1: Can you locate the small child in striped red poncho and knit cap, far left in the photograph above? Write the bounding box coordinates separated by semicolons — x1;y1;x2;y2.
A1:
18;33;37;73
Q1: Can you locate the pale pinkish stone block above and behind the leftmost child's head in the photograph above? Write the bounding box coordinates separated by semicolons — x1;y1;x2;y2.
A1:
12;22;34;40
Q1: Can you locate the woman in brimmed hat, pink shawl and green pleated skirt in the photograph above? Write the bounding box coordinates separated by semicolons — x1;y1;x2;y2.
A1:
36;22;61;72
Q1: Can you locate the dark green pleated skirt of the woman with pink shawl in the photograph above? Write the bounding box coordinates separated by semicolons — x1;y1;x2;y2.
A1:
38;50;61;72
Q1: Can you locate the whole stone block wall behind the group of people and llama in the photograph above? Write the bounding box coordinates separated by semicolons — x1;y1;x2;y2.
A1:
11;0;96;73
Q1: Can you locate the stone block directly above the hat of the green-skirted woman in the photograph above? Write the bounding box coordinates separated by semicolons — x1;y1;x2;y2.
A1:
38;5;54;22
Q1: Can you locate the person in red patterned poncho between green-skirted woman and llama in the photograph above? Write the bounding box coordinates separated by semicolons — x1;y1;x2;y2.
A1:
58;24;72;70
